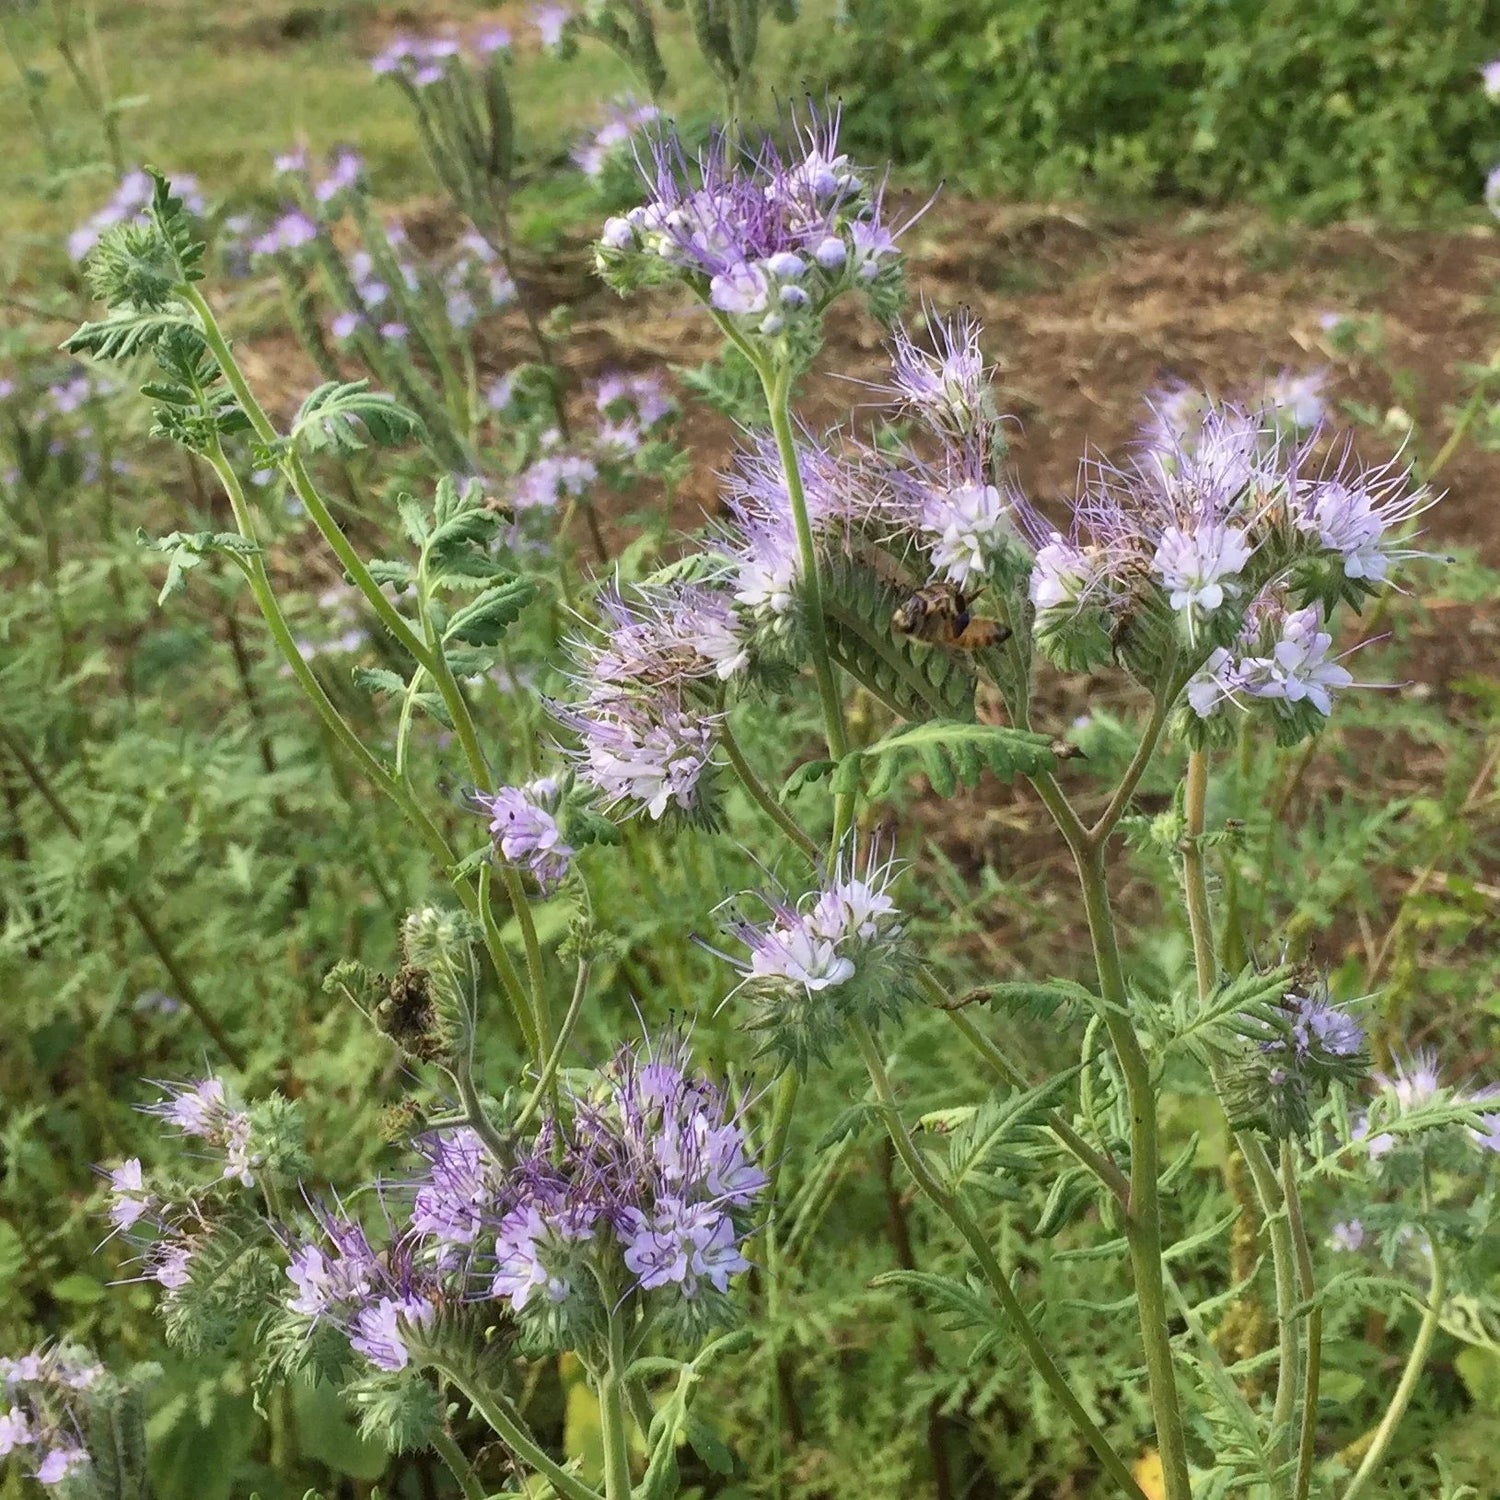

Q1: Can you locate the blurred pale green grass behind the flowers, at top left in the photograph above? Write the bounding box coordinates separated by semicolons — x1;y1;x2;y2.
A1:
0;0;825;287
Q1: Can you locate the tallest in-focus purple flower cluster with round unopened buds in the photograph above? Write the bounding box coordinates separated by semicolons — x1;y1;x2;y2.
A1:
596;105;900;336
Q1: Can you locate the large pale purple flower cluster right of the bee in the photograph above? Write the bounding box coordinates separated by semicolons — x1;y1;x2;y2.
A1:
1023;402;1431;684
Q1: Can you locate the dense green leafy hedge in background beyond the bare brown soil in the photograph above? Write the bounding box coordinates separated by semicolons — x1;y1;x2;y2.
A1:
833;0;1500;216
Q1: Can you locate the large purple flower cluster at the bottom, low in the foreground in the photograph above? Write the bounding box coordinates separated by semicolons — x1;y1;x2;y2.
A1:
287;1041;767;1370
